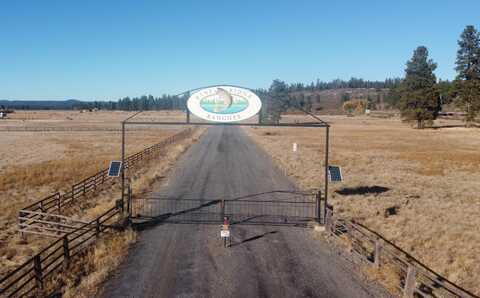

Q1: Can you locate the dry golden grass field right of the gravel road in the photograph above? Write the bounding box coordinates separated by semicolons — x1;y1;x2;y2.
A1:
247;116;480;295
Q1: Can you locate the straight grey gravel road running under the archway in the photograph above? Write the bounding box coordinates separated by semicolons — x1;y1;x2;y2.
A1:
102;126;383;297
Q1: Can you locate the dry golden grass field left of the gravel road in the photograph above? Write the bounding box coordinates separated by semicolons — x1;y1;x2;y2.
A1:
0;111;204;280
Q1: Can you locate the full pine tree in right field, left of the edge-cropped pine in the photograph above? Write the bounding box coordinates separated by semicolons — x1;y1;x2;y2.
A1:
399;46;440;128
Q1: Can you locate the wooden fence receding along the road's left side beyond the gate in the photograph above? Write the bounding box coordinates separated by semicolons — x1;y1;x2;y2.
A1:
18;128;192;232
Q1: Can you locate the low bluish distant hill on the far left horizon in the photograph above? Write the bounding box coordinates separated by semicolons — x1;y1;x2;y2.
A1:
0;99;86;110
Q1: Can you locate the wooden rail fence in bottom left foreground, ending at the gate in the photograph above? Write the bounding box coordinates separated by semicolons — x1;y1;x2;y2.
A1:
0;205;122;297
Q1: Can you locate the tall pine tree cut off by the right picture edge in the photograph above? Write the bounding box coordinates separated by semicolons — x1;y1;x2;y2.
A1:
455;26;480;126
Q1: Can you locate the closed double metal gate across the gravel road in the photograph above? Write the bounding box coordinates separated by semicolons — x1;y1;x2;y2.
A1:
131;191;323;226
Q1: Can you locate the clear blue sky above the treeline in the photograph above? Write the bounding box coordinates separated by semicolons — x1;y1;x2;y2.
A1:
0;0;480;100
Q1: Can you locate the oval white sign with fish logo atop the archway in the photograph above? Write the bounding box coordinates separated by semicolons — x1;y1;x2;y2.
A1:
187;86;262;122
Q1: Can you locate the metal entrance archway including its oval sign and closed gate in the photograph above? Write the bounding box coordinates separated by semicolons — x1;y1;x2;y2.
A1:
122;85;330;226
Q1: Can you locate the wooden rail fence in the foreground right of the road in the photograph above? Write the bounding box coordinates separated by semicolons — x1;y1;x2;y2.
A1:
325;207;478;298
